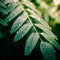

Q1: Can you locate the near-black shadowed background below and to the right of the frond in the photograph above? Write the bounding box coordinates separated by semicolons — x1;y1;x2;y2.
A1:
0;24;60;60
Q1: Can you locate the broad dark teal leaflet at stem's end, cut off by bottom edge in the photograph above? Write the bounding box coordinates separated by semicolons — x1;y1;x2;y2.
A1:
40;42;56;60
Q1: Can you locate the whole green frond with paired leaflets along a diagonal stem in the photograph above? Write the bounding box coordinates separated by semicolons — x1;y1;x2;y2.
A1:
0;0;60;60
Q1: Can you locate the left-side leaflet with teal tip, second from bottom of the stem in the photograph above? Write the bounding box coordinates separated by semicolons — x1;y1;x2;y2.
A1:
14;24;32;42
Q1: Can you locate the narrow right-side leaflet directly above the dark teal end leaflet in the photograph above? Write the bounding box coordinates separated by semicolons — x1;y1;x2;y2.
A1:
41;33;60;50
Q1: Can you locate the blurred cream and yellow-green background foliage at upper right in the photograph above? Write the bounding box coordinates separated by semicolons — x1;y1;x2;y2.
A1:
30;0;60;41
